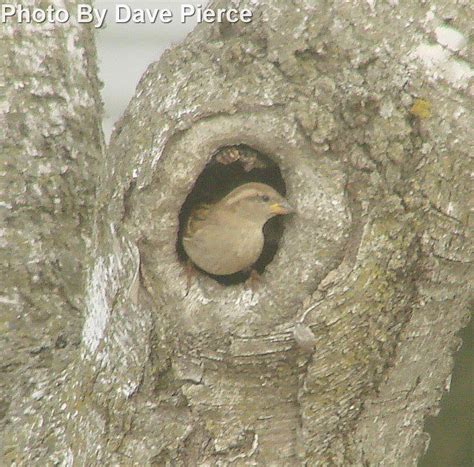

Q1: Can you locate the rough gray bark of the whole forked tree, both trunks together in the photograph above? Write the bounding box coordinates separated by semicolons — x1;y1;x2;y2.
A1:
1;0;474;465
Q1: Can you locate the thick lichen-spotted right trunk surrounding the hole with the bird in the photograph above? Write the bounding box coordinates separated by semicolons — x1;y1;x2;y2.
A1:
2;1;473;465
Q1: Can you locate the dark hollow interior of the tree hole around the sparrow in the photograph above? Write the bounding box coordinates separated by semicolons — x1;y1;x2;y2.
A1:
176;145;286;285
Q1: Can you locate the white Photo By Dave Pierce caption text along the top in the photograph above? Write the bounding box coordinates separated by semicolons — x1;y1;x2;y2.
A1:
0;3;252;28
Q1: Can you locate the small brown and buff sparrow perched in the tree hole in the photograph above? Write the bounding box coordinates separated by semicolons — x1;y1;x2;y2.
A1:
183;183;294;276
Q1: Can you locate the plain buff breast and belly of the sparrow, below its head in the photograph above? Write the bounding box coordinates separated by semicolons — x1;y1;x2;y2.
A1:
183;219;264;275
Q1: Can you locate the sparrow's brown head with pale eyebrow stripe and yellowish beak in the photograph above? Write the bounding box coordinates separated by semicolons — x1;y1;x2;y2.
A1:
219;183;294;224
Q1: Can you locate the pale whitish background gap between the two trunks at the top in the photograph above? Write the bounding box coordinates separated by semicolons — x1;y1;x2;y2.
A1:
94;0;202;142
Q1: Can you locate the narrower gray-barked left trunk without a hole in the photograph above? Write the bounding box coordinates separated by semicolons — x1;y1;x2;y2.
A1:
0;1;103;465
